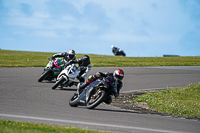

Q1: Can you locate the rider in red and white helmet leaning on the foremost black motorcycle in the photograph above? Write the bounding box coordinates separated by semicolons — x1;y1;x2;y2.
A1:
77;69;124;104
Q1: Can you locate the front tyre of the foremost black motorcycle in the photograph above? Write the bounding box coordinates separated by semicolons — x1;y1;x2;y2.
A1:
87;90;106;109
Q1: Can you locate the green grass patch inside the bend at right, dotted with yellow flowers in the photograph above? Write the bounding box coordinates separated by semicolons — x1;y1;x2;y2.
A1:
133;84;200;118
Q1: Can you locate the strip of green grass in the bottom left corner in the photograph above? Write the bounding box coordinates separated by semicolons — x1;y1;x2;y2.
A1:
0;120;109;133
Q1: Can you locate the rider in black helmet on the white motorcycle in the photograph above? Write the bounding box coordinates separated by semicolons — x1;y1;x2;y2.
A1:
66;55;91;84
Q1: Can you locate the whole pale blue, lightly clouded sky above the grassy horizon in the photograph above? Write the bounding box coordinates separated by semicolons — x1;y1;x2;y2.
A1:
0;0;200;57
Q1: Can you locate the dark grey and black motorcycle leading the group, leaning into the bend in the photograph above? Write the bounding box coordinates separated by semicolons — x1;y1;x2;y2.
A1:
69;75;117;109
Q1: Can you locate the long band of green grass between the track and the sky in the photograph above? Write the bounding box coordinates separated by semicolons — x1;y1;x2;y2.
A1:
0;50;200;67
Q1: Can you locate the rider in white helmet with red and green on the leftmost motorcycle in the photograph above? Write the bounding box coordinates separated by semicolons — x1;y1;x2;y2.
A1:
50;49;76;63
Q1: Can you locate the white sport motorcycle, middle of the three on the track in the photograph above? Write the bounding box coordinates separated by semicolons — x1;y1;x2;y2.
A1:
52;64;80;90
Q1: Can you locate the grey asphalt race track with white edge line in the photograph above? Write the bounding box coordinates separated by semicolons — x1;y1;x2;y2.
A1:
0;66;200;133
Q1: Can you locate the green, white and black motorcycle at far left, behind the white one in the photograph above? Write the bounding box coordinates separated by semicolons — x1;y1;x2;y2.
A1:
38;58;64;82
